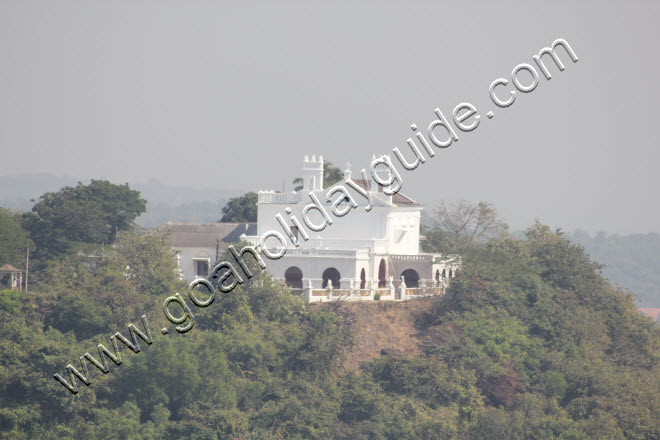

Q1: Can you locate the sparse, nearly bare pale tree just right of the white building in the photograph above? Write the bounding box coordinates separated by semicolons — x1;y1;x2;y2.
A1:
424;200;508;253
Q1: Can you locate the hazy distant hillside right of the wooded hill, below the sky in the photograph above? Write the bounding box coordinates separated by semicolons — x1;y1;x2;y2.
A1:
566;230;660;307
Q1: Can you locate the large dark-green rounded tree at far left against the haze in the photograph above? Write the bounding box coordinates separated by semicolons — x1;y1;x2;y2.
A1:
23;179;147;256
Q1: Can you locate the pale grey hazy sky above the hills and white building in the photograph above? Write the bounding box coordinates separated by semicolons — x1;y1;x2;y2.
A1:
0;0;660;233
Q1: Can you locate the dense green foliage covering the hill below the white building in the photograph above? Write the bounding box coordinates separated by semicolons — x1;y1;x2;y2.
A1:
0;225;660;440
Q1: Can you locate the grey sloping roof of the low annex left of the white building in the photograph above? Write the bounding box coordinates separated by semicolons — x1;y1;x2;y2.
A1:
156;222;257;248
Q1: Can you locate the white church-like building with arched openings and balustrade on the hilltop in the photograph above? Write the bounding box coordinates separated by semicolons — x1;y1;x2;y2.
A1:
241;156;460;301
